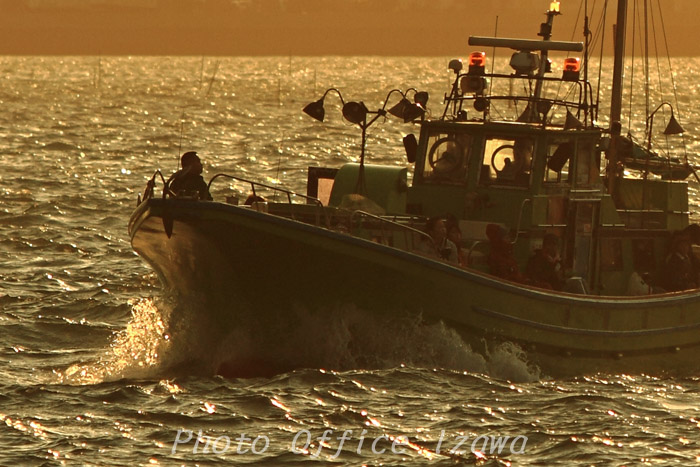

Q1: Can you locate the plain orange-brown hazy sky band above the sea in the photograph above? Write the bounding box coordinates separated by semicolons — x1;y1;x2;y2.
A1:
0;0;700;56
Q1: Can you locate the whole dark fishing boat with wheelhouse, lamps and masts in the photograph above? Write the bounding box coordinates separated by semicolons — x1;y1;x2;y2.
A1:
129;0;700;376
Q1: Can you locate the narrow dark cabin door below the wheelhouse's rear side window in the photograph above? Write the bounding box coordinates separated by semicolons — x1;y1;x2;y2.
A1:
566;199;600;284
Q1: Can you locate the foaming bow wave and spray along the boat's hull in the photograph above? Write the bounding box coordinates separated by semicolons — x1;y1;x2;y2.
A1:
62;299;541;384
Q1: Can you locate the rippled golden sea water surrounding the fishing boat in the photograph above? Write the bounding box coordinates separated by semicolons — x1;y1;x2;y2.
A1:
0;53;700;466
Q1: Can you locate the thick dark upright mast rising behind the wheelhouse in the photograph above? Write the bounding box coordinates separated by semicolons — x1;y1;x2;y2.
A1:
607;0;627;198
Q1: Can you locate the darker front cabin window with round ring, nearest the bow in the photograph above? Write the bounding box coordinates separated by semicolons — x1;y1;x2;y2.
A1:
423;133;472;183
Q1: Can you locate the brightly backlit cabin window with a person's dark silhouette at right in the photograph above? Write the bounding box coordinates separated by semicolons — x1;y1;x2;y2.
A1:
479;137;535;186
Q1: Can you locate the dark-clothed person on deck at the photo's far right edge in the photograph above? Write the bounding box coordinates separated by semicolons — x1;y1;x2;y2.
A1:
663;231;700;292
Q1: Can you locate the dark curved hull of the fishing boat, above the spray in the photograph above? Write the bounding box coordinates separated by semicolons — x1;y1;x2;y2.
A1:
129;199;700;376
